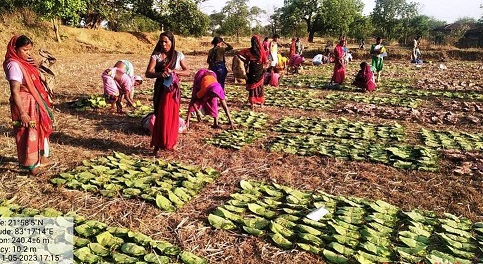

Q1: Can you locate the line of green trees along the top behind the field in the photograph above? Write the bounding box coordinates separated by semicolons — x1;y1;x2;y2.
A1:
0;0;483;44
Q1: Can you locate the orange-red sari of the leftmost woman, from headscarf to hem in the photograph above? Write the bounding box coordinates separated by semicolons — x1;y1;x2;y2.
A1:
3;36;52;167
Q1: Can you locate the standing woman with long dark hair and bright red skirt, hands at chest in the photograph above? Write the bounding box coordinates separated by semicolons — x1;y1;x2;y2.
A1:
146;31;190;156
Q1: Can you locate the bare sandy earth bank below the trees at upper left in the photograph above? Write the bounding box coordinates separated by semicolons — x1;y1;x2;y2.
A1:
0;11;216;55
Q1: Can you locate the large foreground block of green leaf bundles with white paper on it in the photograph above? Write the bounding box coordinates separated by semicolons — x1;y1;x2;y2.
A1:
208;180;483;263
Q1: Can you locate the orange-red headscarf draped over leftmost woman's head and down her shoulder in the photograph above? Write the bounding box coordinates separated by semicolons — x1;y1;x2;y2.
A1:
3;35;53;137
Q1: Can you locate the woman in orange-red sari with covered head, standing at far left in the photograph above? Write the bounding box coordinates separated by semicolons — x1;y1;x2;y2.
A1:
3;35;53;175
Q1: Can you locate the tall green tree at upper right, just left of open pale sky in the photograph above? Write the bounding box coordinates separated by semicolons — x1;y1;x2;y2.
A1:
372;0;418;39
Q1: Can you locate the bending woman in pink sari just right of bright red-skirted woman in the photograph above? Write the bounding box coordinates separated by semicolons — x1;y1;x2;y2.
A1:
186;69;234;129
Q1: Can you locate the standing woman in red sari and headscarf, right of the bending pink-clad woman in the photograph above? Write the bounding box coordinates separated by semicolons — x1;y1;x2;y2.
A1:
238;35;267;109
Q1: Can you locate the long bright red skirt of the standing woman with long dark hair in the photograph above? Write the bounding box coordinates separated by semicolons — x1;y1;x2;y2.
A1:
151;86;180;150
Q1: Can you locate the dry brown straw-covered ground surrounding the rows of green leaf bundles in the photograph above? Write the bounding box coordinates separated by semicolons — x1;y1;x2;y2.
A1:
0;50;483;263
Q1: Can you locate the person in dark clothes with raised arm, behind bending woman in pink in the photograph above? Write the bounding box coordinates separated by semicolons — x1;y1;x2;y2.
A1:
206;37;233;89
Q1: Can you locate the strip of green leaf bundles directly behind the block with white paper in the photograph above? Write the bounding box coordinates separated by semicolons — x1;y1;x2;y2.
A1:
269;135;439;171
